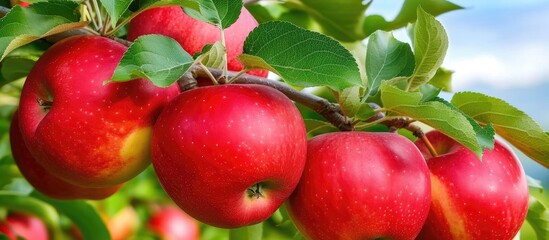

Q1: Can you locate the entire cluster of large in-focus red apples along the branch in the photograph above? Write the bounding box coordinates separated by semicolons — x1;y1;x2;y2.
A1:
10;7;528;240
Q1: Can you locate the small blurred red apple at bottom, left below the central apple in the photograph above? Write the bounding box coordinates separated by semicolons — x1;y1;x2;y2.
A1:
147;206;200;240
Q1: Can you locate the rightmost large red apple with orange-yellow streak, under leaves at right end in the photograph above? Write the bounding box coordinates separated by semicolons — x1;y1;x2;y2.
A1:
416;131;528;240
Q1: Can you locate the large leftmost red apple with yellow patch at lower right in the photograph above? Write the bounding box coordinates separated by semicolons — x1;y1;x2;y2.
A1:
19;36;179;188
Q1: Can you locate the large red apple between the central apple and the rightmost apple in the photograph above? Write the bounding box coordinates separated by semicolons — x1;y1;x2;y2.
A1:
287;132;431;240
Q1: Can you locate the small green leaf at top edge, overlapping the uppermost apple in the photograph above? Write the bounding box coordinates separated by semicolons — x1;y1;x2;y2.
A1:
185;0;243;29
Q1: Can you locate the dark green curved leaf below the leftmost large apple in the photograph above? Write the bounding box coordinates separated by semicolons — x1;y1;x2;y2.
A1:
31;191;111;240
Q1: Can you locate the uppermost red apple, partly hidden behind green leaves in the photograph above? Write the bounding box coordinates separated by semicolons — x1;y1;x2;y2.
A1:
128;7;268;78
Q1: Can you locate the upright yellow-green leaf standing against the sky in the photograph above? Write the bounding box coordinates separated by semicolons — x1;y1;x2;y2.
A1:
407;8;448;90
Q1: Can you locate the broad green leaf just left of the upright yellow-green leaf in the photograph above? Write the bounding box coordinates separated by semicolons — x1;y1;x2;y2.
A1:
366;31;415;96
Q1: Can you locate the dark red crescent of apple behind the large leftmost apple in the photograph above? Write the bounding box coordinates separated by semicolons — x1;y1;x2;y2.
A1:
10;112;120;200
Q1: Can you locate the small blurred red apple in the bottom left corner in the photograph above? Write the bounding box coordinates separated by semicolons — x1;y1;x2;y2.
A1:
0;213;49;240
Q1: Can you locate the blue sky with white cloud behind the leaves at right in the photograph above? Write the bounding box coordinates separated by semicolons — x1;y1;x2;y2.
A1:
368;0;549;184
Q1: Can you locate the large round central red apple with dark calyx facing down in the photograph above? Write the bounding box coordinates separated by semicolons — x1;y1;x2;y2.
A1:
152;85;307;228
